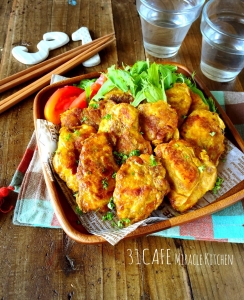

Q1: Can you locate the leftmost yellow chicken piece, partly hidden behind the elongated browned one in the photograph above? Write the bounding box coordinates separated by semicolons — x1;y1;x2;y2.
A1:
52;125;96;192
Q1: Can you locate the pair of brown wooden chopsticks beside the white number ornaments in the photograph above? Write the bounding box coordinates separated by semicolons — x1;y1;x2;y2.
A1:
0;33;115;113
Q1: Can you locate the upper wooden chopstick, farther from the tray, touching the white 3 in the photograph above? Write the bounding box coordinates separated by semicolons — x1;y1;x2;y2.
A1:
0;33;114;93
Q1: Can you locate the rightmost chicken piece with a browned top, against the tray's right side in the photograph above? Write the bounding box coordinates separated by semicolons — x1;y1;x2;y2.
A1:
180;109;225;165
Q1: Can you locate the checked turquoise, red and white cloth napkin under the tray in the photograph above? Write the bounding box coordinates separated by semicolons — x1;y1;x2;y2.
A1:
4;92;244;243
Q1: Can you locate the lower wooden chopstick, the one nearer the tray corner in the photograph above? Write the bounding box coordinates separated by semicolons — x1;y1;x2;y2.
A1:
0;37;115;113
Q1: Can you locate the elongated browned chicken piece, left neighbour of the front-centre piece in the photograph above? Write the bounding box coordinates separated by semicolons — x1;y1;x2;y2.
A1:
76;132;118;213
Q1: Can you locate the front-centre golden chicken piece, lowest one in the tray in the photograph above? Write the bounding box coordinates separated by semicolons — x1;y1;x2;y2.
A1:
113;154;169;225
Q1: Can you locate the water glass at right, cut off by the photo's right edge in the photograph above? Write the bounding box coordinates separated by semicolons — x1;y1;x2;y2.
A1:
201;0;244;82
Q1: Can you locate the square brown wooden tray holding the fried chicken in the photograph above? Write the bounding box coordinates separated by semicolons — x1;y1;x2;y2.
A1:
34;62;244;244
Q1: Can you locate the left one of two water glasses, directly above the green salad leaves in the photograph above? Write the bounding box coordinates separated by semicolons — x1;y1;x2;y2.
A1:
136;0;205;58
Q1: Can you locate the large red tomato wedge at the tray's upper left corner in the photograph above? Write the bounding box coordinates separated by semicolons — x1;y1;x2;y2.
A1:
44;86;84;124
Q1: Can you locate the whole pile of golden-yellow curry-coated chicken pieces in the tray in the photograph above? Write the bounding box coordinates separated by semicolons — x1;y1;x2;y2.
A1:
55;84;224;218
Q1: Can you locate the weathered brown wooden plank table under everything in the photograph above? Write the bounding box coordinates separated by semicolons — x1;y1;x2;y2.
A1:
0;0;244;300
